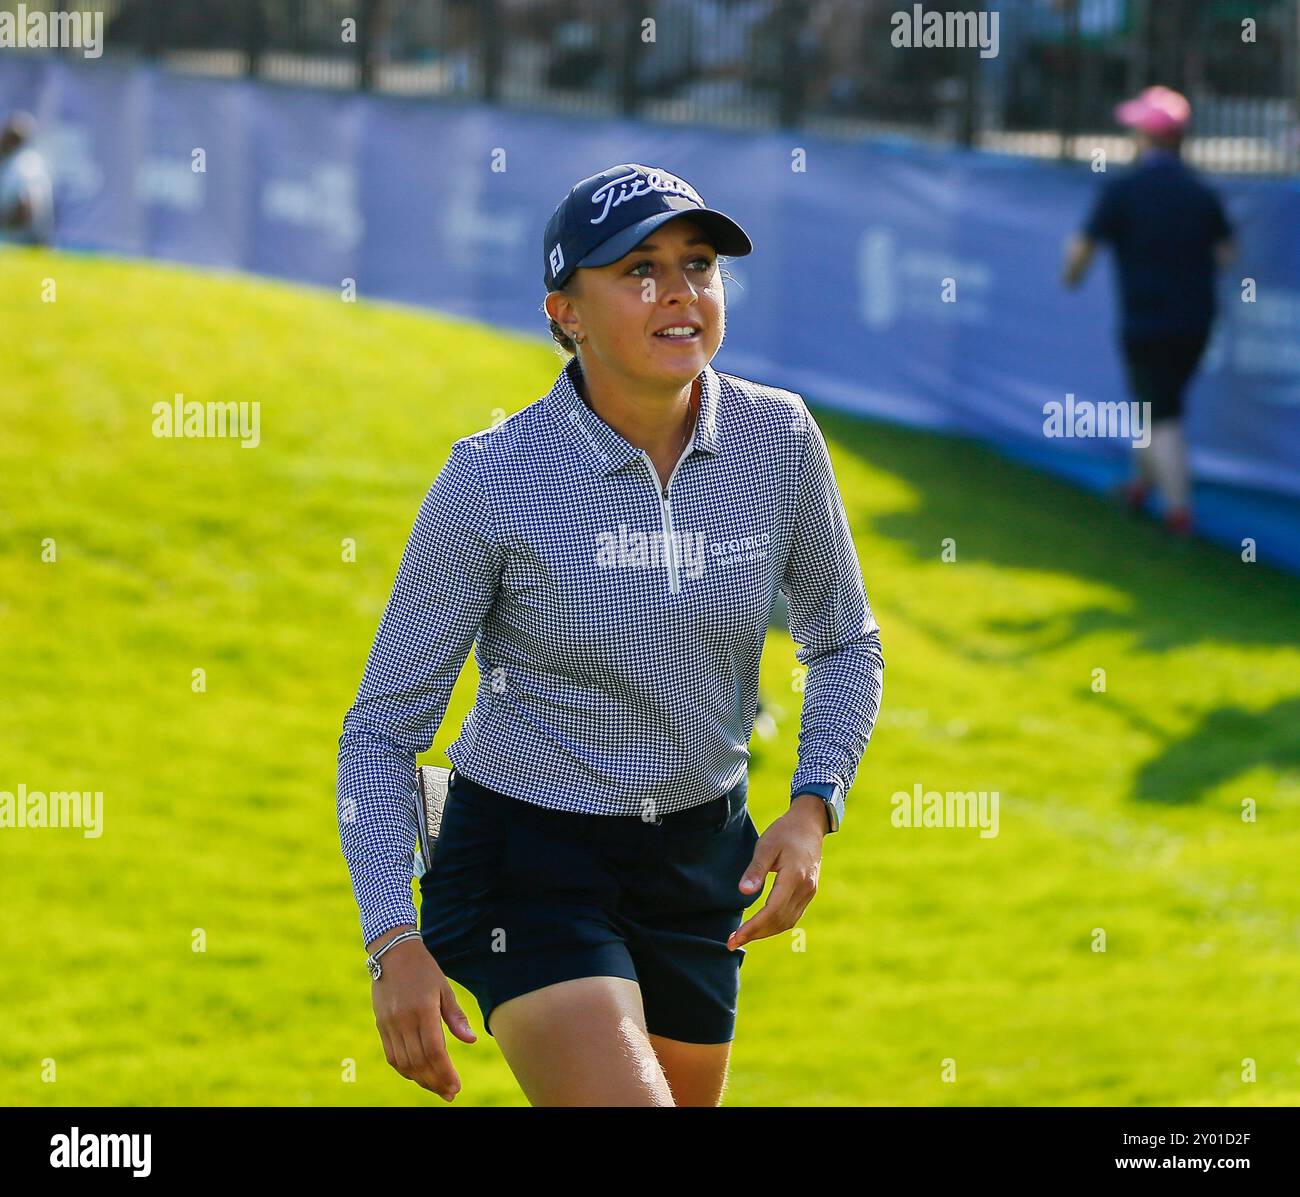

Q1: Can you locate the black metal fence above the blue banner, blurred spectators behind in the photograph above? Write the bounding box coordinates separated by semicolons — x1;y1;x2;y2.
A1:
0;0;1300;172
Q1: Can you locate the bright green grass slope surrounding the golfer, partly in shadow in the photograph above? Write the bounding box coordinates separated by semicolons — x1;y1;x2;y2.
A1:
0;251;1300;1107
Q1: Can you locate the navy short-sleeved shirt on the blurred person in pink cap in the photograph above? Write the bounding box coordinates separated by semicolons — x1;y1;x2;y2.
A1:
1083;149;1232;338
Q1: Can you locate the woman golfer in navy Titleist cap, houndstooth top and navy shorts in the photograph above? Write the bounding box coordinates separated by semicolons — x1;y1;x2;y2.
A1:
338;164;884;1106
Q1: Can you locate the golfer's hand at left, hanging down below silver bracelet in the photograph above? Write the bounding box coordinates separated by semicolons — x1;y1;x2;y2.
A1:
369;927;478;1101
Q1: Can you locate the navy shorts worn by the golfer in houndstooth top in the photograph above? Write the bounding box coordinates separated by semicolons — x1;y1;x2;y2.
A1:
420;769;761;1044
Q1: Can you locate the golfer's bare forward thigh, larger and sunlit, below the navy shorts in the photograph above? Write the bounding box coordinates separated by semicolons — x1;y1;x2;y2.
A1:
491;977;673;1106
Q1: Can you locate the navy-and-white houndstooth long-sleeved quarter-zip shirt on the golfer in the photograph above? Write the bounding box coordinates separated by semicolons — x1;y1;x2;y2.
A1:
338;359;884;945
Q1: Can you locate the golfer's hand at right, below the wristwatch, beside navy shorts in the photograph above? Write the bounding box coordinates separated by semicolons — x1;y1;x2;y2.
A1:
727;794;827;949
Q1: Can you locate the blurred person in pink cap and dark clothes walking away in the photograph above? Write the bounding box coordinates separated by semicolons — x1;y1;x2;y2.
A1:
1063;87;1234;537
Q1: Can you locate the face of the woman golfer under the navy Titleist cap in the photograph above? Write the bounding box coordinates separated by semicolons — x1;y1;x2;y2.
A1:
581;217;725;385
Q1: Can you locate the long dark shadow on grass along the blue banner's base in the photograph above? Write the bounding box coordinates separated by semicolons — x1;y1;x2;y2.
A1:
816;409;1300;660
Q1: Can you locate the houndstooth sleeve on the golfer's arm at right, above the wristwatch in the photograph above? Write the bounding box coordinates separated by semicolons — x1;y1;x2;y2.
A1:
780;407;885;795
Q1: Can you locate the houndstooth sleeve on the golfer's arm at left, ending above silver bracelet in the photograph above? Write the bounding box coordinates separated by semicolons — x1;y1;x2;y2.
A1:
337;439;502;945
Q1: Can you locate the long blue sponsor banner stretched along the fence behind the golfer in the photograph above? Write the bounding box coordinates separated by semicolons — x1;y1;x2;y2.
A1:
0;53;1300;571
